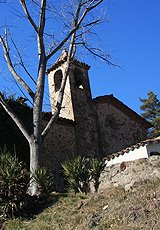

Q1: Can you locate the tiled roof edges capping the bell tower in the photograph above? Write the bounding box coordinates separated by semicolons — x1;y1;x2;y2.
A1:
46;50;90;74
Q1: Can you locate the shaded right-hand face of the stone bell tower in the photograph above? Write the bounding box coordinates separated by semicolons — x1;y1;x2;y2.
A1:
70;62;99;157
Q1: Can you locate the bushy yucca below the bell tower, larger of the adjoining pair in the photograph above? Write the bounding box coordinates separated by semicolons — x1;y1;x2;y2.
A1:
62;156;89;194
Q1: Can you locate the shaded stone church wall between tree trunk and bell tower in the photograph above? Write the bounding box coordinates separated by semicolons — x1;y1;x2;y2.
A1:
42;118;77;172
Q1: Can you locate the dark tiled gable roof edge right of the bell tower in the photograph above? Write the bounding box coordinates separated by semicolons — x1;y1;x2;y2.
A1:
93;94;152;129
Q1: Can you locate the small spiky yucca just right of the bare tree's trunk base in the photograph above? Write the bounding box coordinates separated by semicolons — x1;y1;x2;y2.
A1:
33;167;54;196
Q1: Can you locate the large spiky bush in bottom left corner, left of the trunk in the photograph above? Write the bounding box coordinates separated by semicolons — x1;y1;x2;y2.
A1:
0;153;30;217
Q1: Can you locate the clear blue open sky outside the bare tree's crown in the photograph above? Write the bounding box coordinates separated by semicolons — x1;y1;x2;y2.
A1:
0;0;160;114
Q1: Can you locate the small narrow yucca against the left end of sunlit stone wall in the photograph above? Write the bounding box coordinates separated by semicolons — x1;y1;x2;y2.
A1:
90;158;106;192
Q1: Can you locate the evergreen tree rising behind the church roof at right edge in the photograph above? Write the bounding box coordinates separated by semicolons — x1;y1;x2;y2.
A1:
139;90;160;138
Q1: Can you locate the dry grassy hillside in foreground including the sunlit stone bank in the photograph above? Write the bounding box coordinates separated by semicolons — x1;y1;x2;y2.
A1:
2;156;160;230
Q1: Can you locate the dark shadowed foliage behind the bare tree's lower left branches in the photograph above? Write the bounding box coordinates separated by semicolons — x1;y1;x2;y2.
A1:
0;94;32;166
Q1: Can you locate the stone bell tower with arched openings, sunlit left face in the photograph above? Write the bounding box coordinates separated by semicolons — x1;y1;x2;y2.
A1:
47;51;99;157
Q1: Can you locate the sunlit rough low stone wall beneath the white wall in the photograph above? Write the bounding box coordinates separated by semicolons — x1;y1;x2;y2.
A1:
91;156;160;193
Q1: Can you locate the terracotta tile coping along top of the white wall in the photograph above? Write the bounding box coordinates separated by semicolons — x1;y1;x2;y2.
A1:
103;137;160;161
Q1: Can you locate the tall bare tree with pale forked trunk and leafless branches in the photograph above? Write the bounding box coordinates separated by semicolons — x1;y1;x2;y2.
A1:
0;0;114;195
